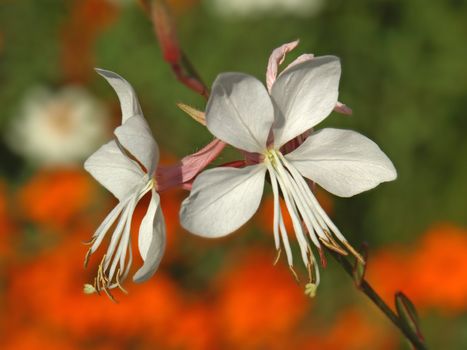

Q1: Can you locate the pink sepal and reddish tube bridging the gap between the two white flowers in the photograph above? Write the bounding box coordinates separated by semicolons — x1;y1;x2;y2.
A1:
156;139;225;191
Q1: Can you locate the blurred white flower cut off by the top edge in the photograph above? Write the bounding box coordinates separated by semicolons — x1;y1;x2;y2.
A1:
208;0;324;17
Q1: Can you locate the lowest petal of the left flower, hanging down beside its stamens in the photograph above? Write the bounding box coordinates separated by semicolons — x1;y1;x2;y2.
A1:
133;189;166;282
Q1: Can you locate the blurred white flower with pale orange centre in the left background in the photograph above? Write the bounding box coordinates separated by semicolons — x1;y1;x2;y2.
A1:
5;86;109;165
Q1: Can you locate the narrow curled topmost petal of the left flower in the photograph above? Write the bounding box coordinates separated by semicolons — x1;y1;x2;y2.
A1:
96;68;143;124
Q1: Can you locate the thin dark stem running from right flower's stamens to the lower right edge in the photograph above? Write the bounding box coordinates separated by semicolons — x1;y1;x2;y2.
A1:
327;249;427;350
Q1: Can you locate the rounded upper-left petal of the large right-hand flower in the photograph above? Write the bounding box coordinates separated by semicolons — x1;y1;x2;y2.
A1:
206;73;274;152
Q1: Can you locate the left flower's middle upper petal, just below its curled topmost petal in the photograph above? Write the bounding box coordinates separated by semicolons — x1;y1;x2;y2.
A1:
115;115;159;175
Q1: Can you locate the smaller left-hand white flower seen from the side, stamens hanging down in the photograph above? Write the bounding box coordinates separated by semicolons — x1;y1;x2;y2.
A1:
84;69;166;299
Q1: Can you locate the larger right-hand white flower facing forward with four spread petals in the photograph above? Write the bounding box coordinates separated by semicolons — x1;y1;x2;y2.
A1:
180;56;396;285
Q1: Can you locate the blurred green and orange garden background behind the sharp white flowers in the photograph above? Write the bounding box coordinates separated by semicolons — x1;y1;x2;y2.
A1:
0;0;467;350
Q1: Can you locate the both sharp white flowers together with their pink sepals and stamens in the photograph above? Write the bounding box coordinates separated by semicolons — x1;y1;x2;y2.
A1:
85;42;397;295
